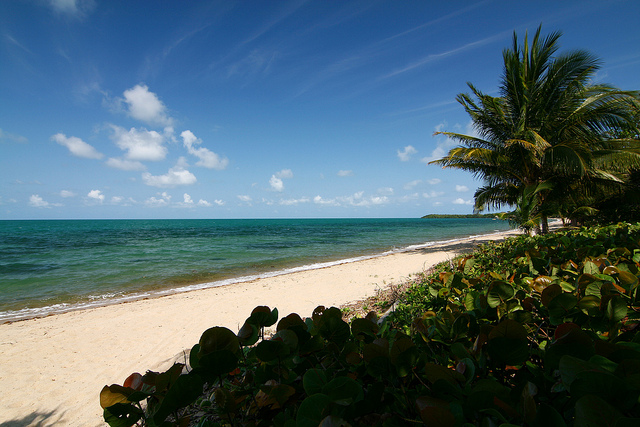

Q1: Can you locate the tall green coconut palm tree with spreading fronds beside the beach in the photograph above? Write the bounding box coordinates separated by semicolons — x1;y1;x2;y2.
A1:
431;27;640;232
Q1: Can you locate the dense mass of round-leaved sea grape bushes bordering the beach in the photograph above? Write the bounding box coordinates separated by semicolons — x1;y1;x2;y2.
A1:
100;224;640;427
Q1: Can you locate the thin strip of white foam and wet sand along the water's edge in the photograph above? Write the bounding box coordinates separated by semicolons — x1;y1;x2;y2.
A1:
0;230;512;325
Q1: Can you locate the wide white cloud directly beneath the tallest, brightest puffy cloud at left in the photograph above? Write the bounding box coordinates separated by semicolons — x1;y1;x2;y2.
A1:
111;125;167;161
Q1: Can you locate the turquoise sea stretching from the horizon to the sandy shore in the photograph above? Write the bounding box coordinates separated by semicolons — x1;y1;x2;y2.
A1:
0;219;509;322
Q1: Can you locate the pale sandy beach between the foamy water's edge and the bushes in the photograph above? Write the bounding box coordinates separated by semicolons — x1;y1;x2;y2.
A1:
0;231;516;426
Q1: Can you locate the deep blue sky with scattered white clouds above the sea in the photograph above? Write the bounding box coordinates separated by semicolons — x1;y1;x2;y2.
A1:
0;0;640;219
